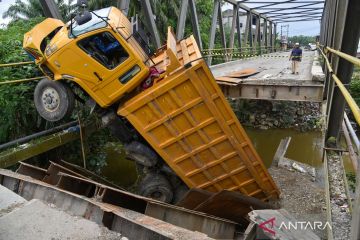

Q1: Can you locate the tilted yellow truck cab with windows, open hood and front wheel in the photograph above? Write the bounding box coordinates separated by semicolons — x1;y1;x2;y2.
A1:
24;7;149;121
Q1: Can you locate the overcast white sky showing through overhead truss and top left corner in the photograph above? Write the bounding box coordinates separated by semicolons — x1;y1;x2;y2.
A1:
0;0;323;36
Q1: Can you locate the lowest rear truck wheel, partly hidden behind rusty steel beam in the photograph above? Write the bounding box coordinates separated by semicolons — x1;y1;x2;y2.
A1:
138;173;173;203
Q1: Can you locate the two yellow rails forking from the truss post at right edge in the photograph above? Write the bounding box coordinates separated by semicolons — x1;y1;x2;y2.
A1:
318;47;360;126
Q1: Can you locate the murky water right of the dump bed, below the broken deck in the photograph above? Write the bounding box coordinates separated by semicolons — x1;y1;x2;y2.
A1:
246;128;323;167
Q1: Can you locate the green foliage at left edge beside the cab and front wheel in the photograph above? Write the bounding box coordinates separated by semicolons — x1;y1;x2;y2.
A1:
0;18;42;143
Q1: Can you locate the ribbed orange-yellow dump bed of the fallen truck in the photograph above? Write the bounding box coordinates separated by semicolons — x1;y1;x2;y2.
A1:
118;30;279;200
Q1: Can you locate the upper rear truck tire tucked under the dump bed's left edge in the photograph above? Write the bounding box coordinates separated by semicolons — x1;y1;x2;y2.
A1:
124;141;159;167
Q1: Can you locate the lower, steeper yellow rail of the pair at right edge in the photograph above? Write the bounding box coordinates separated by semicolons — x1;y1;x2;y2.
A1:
319;48;360;126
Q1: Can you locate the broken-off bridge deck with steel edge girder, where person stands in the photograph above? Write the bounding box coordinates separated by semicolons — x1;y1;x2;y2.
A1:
210;51;323;102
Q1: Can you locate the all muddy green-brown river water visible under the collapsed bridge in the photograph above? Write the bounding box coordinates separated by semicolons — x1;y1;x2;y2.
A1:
102;128;352;187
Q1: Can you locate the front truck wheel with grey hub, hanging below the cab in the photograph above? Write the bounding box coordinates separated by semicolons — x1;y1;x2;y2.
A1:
34;79;75;122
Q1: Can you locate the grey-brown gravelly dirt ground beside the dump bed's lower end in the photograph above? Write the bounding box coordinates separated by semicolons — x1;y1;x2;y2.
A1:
269;167;326;239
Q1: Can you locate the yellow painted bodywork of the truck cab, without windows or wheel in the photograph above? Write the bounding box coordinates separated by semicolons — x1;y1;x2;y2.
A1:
24;7;149;108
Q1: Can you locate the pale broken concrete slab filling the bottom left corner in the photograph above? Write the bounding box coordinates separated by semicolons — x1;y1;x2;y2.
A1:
0;199;122;240
